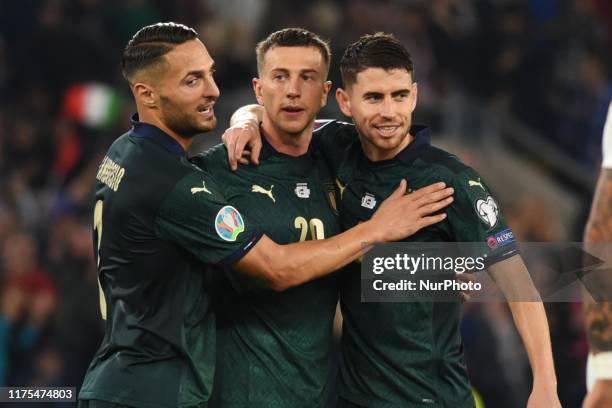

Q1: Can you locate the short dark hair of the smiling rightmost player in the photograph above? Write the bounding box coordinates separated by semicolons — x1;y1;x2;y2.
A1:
340;32;414;88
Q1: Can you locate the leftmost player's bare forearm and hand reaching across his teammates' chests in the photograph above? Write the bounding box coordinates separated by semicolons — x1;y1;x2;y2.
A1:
236;181;453;291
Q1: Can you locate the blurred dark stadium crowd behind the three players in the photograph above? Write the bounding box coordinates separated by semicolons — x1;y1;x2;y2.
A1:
0;0;612;407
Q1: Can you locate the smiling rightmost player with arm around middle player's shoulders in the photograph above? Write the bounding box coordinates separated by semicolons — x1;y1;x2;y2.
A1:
226;33;560;408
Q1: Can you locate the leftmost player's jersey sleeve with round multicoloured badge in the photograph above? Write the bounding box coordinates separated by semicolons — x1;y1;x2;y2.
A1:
155;171;262;266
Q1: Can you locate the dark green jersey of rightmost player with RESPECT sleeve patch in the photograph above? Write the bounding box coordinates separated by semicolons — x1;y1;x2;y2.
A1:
319;121;516;408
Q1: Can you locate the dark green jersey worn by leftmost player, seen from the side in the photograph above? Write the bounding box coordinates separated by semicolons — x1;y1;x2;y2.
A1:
79;117;261;408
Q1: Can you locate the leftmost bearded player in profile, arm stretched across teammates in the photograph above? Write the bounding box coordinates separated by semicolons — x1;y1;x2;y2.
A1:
79;23;446;408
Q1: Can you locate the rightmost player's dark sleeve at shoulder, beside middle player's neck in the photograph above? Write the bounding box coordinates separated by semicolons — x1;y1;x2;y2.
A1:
313;119;359;174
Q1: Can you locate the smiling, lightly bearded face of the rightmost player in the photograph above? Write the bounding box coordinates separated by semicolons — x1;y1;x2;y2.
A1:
336;68;417;161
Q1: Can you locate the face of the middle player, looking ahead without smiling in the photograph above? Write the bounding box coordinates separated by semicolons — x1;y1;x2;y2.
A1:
253;46;331;136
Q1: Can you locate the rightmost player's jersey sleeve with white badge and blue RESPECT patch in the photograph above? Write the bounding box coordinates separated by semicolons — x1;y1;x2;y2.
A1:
447;167;518;266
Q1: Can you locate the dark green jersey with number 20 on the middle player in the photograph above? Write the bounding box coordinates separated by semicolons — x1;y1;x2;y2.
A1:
198;134;340;408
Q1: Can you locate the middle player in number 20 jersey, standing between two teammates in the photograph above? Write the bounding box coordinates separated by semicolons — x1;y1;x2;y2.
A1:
196;28;450;408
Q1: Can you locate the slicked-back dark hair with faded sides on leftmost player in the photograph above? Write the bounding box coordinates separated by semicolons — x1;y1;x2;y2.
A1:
121;22;198;83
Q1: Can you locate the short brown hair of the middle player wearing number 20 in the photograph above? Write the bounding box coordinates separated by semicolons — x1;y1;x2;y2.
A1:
255;28;331;74
